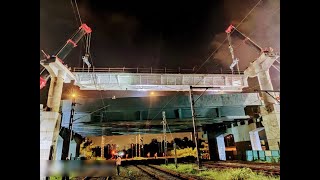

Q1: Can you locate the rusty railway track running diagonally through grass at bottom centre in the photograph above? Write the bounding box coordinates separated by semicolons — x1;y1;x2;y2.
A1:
137;165;184;180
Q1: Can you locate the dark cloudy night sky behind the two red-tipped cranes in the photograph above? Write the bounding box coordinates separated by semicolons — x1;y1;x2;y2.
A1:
39;0;280;102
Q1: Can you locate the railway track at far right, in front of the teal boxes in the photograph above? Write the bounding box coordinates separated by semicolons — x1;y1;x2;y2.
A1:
203;162;280;176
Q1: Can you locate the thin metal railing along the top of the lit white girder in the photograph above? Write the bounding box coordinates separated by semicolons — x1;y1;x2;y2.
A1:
73;67;244;75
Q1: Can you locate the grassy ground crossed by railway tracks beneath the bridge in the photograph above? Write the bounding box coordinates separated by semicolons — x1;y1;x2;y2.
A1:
63;161;280;180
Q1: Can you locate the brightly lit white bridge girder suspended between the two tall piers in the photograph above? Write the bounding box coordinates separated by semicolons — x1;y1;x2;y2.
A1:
73;72;248;92
